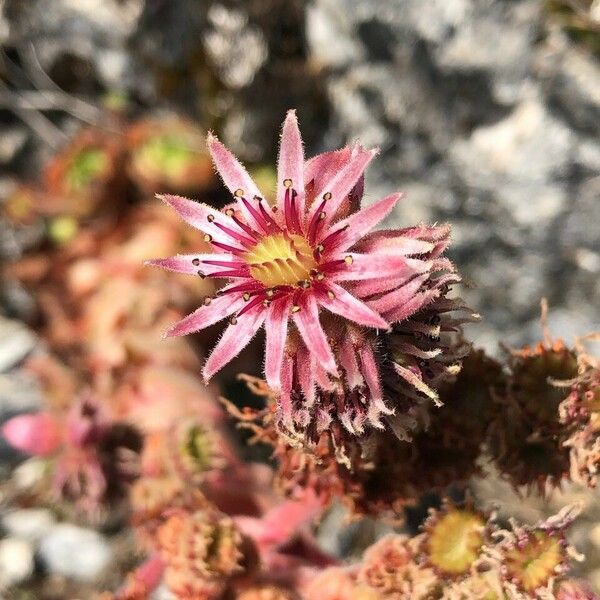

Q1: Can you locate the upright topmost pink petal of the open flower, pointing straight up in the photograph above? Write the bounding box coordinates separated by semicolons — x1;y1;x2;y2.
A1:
277;110;304;222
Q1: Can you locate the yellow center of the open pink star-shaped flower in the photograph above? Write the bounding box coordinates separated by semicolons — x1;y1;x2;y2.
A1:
244;233;317;287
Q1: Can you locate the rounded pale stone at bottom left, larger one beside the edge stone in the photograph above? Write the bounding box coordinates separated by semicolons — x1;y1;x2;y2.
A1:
39;523;112;581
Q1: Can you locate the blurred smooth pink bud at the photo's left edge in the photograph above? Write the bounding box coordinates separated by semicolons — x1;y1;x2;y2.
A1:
1;413;62;456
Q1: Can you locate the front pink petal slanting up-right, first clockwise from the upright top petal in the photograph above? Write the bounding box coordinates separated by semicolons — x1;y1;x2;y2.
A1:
308;148;377;231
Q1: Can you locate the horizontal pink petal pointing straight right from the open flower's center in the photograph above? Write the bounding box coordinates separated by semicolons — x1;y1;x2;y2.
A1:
328;252;427;281
